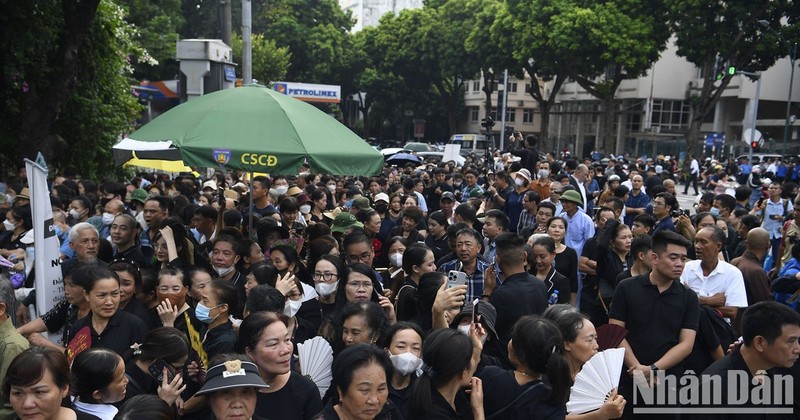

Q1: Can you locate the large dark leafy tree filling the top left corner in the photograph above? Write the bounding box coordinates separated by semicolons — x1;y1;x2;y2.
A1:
0;0;146;176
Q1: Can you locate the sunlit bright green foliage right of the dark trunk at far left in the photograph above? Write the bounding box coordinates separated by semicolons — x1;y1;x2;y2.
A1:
53;0;146;179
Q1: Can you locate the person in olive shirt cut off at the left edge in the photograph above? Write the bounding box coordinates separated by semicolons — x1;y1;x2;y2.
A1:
0;278;29;419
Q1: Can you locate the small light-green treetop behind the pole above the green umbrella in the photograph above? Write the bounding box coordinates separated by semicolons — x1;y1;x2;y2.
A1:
232;33;291;85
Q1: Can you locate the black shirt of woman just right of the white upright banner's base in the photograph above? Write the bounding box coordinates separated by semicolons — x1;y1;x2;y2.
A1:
69;310;148;355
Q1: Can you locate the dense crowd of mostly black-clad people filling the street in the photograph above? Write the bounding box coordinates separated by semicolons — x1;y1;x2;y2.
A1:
0;137;800;420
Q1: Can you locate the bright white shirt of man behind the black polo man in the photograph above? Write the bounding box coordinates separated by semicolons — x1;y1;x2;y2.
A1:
681;260;747;322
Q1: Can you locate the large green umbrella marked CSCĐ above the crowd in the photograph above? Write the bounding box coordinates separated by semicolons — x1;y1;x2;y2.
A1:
114;85;383;176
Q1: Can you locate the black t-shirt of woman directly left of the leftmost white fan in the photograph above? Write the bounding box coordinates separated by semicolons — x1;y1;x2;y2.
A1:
255;372;322;420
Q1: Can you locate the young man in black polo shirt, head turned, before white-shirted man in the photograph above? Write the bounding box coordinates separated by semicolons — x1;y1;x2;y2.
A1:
608;231;700;417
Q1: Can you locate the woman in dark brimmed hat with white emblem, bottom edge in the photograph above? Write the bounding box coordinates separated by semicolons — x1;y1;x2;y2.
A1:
196;354;268;420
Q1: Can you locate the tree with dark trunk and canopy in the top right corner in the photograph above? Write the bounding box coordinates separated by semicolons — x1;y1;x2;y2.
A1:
665;0;800;153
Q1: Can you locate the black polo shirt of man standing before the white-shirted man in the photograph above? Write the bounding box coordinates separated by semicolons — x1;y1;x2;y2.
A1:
608;273;700;373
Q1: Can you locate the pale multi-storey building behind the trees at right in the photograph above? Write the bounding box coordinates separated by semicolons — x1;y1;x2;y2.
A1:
460;38;800;157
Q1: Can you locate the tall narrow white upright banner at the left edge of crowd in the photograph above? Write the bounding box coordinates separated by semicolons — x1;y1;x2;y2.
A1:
25;159;64;342
